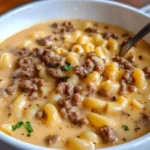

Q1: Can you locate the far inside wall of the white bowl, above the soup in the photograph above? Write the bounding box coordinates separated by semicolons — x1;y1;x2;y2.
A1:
0;0;150;41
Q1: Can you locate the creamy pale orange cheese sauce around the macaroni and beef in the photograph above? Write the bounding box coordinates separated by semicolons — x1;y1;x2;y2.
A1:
0;20;150;149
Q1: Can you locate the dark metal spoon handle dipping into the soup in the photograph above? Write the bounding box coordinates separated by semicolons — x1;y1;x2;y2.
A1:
119;22;150;57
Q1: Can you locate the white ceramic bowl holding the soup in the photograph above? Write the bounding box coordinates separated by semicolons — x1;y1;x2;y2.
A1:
0;0;150;150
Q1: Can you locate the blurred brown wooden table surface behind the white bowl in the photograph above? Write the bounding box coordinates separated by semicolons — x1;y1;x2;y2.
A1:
0;0;150;15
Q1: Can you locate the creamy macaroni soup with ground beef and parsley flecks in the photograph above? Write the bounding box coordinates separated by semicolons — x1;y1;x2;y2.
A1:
0;20;150;150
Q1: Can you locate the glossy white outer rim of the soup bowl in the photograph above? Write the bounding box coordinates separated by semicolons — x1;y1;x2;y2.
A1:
0;0;150;150
